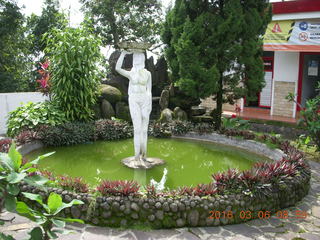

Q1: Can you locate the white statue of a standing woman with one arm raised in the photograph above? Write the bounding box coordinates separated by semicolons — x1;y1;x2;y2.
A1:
116;51;152;166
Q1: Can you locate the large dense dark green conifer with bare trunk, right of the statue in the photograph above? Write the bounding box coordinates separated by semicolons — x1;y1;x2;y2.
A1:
162;0;271;130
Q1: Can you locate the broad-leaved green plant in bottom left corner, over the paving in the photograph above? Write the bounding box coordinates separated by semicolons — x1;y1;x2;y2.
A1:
17;192;83;240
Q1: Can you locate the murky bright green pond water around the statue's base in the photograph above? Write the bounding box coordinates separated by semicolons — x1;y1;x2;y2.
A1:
26;138;267;188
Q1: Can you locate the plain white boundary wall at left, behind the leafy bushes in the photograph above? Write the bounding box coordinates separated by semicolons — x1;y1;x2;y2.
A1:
0;92;47;134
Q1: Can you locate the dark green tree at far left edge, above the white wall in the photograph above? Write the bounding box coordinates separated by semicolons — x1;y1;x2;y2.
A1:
0;0;32;92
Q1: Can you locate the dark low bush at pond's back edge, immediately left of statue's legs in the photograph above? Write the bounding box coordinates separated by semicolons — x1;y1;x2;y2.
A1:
95;119;133;140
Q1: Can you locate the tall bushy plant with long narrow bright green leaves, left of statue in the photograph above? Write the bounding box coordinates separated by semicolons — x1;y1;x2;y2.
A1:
45;26;101;121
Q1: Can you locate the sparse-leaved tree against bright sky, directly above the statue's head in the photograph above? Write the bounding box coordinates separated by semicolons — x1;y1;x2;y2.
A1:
80;0;162;48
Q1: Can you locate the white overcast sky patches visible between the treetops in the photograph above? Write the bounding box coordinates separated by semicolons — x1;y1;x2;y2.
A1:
17;0;173;26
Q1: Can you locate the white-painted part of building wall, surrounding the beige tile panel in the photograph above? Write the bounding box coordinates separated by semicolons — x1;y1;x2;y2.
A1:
271;51;300;117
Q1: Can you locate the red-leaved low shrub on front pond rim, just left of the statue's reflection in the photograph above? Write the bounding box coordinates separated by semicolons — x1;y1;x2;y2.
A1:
97;180;140;196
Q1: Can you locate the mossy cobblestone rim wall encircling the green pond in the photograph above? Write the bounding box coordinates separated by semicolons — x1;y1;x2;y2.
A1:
16;134;310;228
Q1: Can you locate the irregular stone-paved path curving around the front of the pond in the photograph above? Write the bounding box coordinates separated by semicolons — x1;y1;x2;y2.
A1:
0;162;320;240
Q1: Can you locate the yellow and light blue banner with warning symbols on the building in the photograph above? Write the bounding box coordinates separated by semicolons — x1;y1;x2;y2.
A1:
263;20;320;52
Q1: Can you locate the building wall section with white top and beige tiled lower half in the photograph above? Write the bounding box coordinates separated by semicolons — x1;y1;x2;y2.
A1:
271;52;299;117
